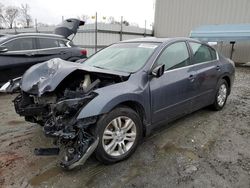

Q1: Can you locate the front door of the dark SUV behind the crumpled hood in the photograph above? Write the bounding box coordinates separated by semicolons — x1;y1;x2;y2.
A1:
0;37;37;83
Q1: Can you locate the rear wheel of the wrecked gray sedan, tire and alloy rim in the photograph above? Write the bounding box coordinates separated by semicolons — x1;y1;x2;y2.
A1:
212;79;229;111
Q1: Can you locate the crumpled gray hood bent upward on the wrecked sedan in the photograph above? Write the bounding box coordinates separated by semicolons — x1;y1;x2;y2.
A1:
21;58;129;96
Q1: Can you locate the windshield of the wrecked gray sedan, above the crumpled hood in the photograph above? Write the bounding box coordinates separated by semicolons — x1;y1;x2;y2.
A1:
84;43;159;73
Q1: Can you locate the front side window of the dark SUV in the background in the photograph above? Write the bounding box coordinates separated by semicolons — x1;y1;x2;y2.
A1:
4;38;34;51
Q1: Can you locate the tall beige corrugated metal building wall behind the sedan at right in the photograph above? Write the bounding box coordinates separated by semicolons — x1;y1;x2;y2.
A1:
154;0;250;62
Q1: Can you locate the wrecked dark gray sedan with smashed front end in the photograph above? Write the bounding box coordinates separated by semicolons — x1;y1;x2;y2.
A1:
1;38;235;169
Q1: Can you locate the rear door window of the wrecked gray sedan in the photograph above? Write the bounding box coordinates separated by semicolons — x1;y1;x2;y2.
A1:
189;42;213;63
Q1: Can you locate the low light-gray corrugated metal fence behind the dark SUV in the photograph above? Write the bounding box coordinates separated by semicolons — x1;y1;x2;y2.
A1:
0;23;152;55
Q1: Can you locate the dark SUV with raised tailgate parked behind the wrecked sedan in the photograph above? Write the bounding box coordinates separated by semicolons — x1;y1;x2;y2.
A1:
0;19;87;85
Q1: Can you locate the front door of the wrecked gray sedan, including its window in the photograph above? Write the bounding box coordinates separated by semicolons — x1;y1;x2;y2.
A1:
150;41;196;124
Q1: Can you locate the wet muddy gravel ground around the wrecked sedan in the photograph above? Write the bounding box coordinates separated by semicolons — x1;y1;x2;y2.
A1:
0;67;250;188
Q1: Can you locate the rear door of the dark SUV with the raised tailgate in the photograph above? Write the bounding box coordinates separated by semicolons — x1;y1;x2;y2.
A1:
36;37;72;62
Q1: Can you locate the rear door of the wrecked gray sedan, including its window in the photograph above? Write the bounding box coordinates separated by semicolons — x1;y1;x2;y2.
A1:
189;42;220;110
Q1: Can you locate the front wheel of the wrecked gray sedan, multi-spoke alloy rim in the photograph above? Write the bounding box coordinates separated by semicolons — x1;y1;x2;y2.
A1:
95;107;142;164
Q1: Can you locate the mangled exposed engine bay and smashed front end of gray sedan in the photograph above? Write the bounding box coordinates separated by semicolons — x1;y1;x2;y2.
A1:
9;70;127;169
